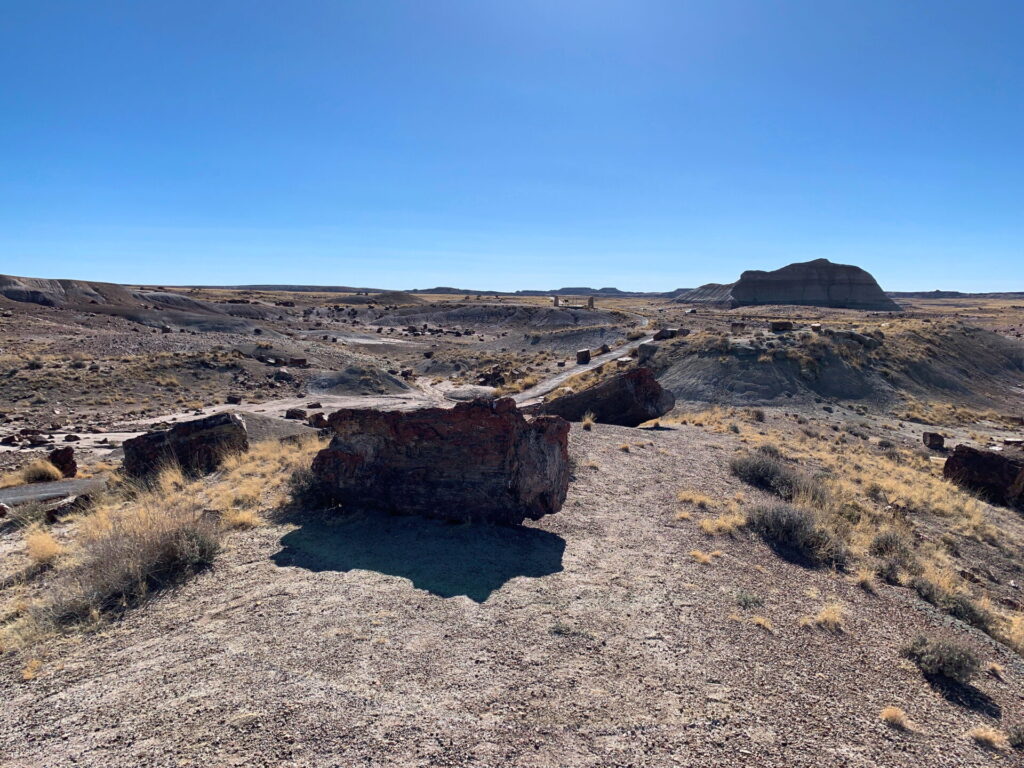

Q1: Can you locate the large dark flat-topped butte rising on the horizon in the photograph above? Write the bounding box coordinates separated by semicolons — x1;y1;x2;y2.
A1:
676;259;900;312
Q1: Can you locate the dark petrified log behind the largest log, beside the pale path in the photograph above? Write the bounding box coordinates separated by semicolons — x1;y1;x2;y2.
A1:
540;368;676;427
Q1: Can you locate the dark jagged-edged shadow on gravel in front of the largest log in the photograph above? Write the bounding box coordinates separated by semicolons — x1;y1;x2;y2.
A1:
271;513;565;603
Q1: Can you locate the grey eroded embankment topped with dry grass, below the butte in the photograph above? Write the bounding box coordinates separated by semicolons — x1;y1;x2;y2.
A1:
652;322;1024;406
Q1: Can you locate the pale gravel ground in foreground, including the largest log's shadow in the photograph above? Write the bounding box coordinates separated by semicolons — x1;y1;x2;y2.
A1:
0;425;1024;768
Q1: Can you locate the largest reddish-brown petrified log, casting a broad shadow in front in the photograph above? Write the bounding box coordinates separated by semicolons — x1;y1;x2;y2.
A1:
312;398;569;524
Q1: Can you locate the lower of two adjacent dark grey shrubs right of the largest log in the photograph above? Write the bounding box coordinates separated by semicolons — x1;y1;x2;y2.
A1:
746;503;849;567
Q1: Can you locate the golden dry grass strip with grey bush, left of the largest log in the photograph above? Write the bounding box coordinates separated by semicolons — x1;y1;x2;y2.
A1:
9;438;323;645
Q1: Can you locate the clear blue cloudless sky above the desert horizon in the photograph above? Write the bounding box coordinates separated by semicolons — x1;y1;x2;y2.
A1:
0;0;1024;291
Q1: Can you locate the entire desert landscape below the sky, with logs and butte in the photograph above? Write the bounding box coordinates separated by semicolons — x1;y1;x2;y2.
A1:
0;261;1024;766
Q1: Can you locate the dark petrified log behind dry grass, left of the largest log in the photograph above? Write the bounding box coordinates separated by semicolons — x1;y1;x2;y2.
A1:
123;414;249;477
